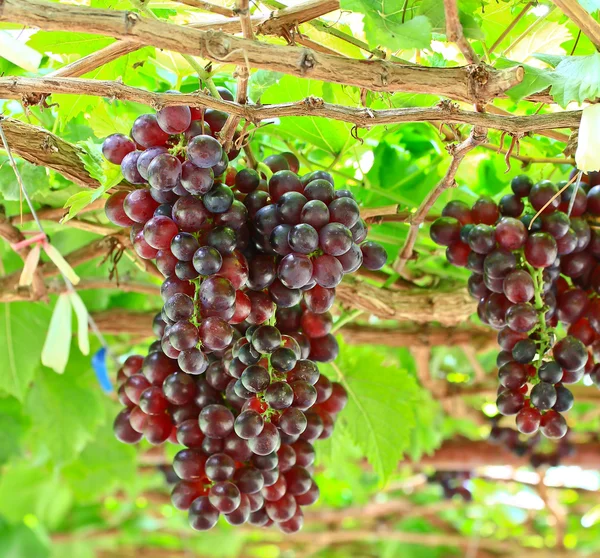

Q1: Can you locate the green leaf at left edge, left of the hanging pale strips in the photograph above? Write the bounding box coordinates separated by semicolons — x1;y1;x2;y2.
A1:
0;302;51;400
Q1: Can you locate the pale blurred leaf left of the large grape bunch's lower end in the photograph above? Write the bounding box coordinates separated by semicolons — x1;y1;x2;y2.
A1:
63;424;137;501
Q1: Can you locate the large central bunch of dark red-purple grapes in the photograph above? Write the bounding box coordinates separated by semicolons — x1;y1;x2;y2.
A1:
103;92;387;533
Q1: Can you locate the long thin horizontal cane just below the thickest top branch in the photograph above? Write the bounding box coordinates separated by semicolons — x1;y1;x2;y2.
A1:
0;77;581;134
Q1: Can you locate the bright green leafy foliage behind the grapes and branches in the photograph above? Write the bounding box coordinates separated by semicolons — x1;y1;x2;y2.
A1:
0;0;600;558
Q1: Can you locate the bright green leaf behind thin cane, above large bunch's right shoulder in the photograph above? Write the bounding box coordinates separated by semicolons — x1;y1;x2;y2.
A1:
261;76;356;155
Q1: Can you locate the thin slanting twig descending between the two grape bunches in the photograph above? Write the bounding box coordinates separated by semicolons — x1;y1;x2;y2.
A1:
394;127;487;274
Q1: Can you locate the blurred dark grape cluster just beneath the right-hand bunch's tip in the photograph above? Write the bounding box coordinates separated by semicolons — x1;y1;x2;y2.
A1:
489;422;575;468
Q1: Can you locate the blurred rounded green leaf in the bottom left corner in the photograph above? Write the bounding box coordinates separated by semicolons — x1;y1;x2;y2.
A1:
0;461;72;527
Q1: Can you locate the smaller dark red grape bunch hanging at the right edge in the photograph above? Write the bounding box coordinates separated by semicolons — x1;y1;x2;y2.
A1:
430;174;600;439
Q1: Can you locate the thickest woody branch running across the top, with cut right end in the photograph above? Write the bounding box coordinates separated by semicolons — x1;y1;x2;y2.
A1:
0;0;524;103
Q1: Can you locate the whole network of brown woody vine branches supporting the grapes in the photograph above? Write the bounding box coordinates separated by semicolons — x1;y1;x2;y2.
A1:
0;0;600;558
